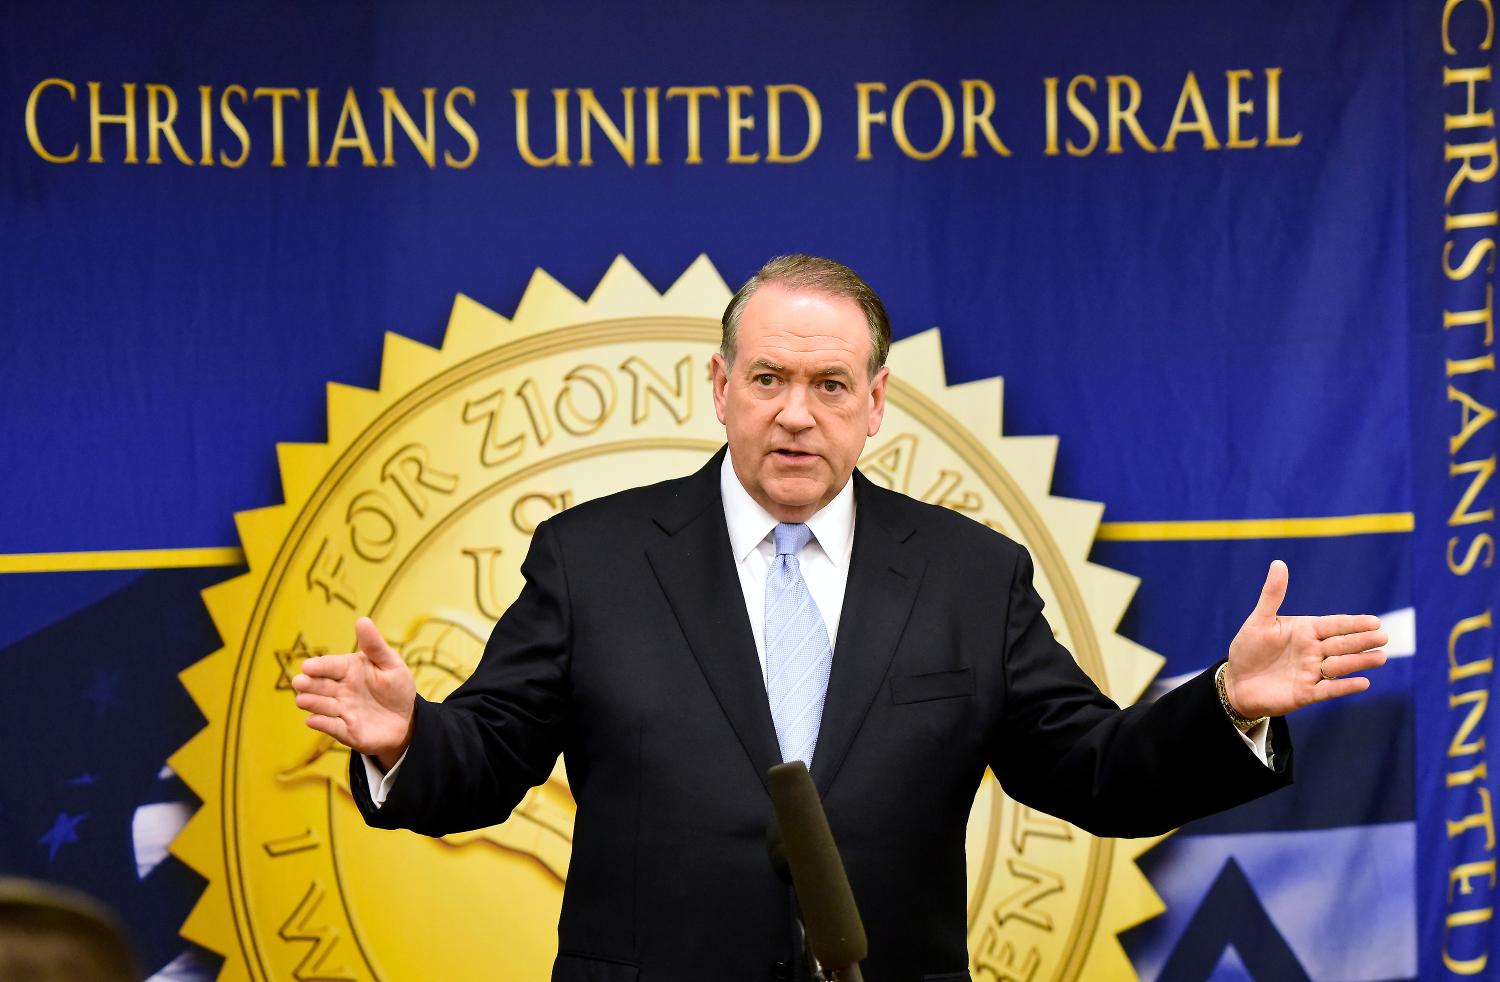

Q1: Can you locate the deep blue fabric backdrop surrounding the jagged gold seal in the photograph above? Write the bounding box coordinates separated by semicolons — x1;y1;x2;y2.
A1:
0;0;1497;979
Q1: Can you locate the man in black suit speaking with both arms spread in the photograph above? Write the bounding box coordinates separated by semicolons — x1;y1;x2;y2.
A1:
293;256;1386;981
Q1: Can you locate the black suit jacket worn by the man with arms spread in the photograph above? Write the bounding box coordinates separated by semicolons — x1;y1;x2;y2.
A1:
351;450;1290;982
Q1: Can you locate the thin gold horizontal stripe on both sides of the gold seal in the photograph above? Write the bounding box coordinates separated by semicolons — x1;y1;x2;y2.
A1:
0;511;1416;573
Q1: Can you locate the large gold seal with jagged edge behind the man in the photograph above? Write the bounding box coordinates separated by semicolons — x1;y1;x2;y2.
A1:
171;258;1161;981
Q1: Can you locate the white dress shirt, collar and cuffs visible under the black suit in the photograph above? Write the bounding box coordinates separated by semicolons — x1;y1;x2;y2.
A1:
365;453;1271;807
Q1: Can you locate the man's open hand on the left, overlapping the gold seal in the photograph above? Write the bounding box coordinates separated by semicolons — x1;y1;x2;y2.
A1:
291;618;417;771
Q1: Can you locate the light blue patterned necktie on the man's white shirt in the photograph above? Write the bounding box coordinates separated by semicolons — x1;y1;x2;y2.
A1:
765;522;834;768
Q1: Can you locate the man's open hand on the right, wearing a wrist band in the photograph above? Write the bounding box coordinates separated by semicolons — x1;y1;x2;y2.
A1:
1224;559;1389;720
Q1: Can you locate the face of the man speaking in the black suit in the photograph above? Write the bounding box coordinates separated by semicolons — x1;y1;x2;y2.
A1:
713;283;888;522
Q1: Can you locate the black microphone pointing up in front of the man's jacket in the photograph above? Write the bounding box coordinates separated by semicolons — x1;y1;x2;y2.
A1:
767;760;869;982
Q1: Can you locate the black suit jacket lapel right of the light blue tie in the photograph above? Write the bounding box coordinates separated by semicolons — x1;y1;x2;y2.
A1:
810;471;926;798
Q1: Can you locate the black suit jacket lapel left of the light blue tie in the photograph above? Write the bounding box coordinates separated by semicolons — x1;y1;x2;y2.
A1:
647;451;782;784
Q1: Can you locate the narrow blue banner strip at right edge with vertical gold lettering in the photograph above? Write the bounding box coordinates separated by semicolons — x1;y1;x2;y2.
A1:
1410;4;1500;978
